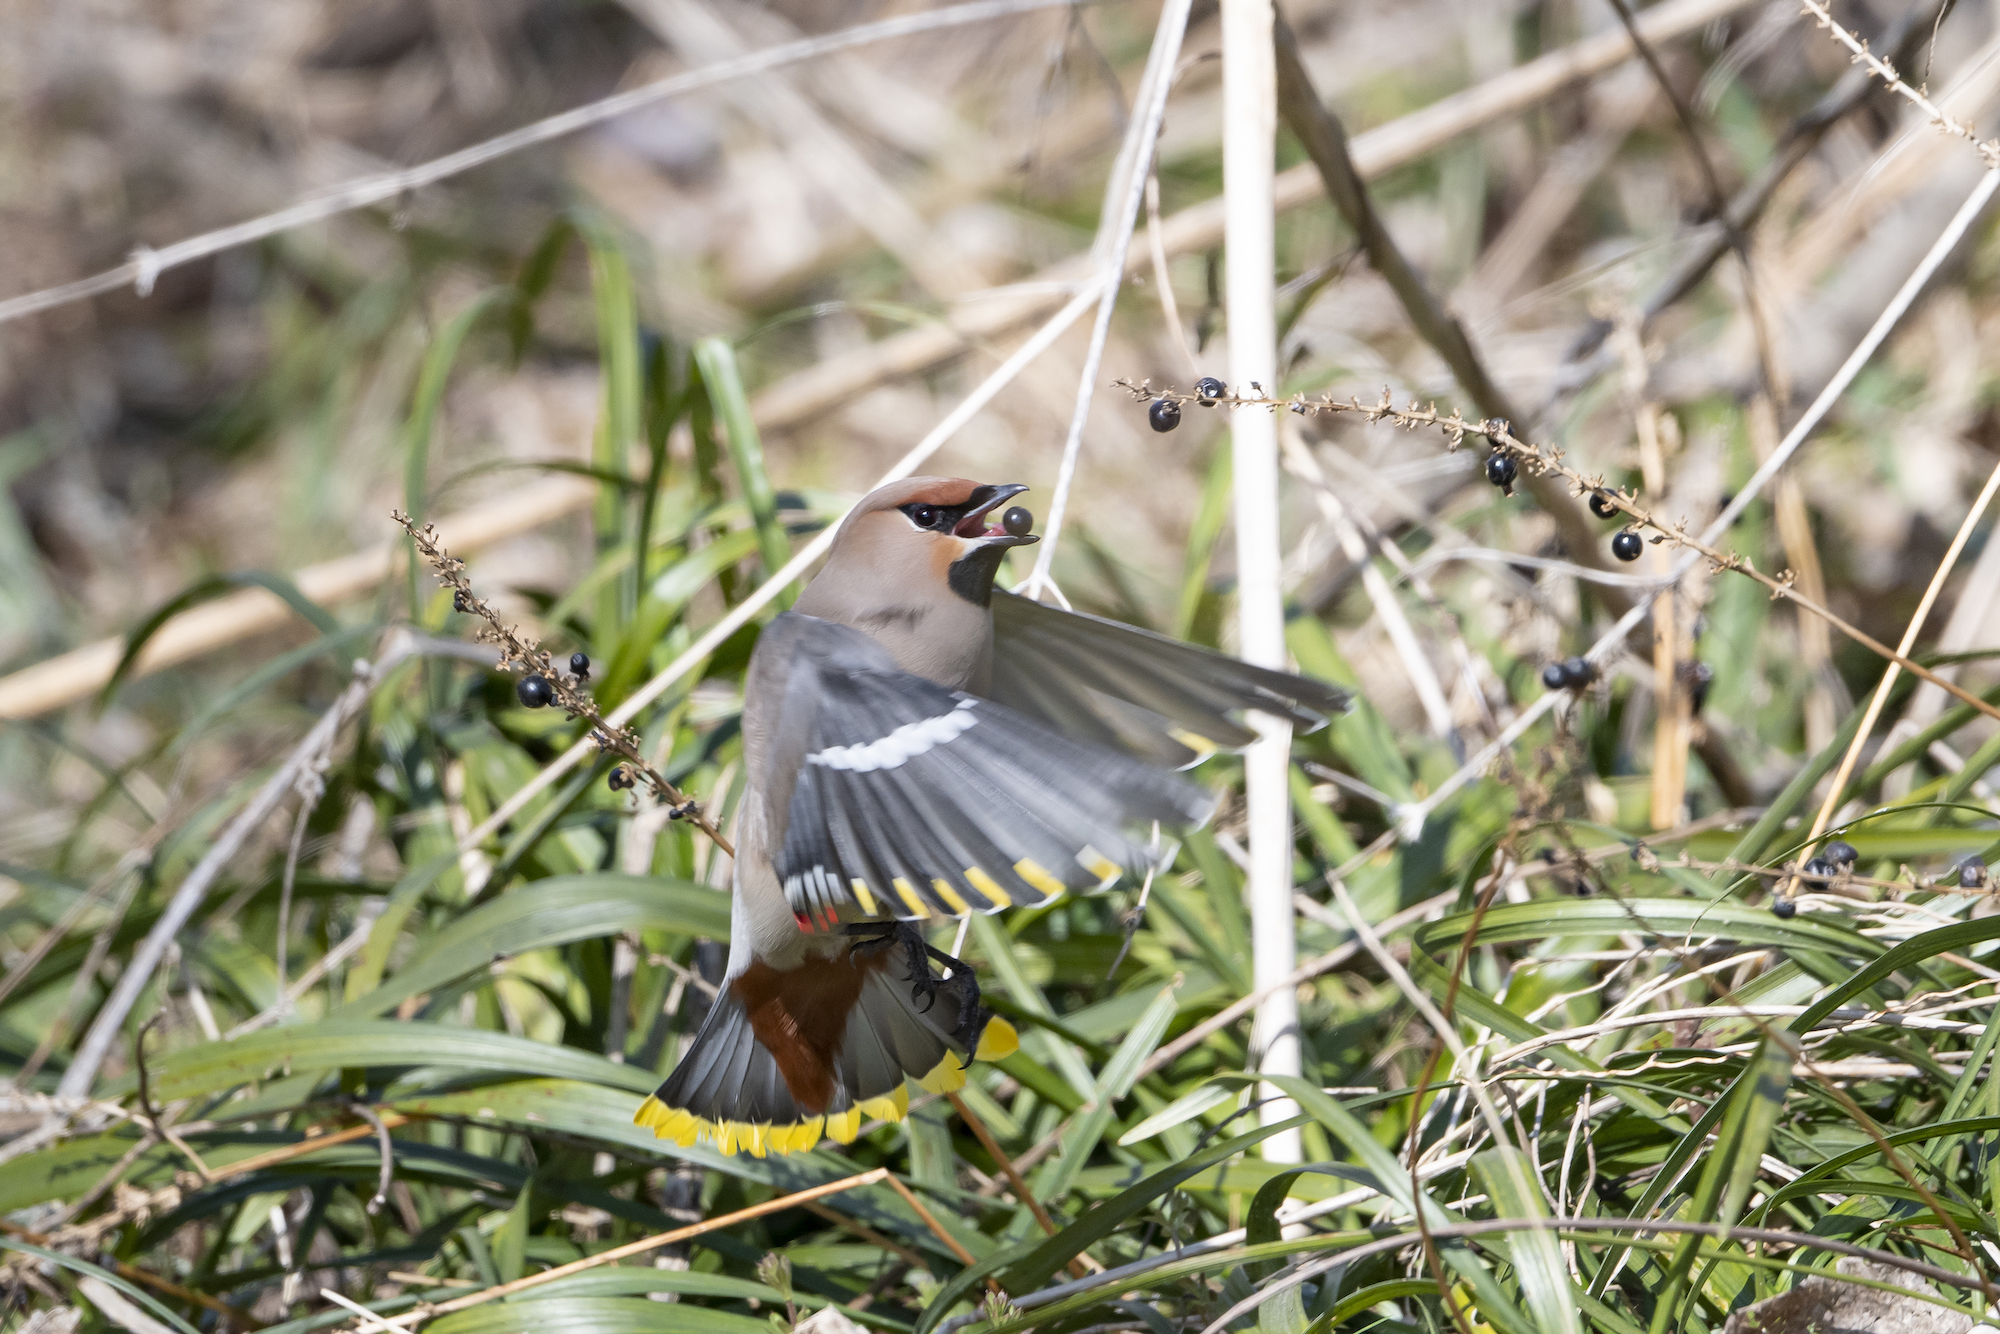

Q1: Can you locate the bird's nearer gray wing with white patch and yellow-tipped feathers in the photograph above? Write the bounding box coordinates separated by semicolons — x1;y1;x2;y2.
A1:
758;612;1214;922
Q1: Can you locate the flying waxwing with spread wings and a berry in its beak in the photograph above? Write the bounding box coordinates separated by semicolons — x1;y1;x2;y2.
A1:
634;476;1348;1158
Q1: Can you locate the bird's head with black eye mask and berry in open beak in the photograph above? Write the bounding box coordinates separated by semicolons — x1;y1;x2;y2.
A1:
834;478;1038;606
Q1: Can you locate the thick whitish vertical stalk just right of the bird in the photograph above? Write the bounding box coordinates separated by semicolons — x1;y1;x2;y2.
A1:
1222;0;1302;1162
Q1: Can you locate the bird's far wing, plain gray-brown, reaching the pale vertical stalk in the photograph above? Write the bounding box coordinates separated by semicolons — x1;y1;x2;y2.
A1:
990;590;1350;768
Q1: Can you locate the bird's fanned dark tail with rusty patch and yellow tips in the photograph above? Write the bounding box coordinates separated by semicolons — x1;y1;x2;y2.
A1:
632;926;1018;1158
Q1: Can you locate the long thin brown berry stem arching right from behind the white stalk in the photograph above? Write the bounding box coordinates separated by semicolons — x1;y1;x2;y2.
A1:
1114;380;2000;720
